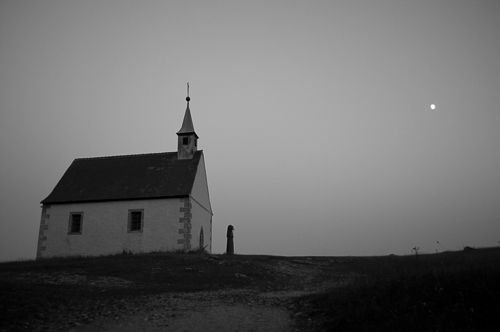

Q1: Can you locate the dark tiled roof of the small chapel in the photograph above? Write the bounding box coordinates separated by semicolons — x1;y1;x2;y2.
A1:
41;151;202;204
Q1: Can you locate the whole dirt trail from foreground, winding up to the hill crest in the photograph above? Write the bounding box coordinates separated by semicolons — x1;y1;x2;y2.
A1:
72;261;332;332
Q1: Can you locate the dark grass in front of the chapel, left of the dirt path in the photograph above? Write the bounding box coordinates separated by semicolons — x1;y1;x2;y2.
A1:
0;253;284;330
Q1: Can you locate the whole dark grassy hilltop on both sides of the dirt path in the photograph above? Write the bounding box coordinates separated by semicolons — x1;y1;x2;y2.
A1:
0;248;500;331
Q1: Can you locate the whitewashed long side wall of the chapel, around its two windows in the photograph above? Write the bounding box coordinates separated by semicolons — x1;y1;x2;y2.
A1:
40;199;184;257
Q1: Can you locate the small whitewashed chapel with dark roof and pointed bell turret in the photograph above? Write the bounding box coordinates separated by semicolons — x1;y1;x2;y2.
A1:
37;94;213;258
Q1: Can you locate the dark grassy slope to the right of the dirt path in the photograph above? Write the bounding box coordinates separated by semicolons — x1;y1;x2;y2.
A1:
297;248;500;331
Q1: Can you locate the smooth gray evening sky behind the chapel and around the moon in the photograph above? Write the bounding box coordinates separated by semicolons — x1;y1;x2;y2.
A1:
0;0;500;260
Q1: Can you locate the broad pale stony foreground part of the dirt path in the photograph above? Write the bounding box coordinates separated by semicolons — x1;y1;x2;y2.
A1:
72;291;294;332
